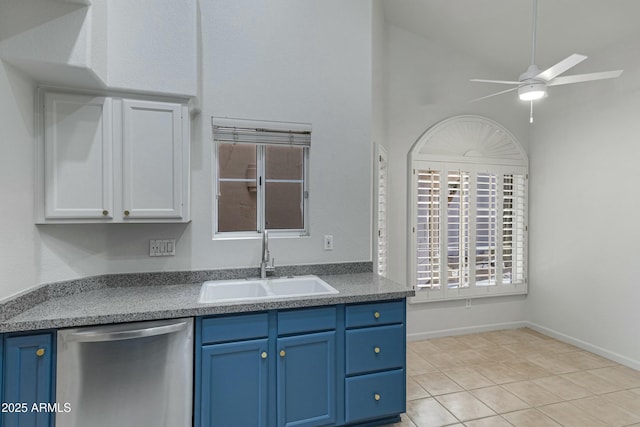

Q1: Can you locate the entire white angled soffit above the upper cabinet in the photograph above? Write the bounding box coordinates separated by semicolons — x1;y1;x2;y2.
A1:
0;0;199;97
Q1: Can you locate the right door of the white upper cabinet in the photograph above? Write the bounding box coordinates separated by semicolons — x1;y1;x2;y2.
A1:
122;99;189;221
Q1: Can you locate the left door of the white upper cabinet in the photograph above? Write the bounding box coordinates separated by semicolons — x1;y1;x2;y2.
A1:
43;93;113;220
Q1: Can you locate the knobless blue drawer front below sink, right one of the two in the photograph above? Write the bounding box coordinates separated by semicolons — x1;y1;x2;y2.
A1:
278;306;336;335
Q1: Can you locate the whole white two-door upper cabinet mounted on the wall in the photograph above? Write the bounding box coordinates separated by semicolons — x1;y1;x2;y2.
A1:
36;92;190;223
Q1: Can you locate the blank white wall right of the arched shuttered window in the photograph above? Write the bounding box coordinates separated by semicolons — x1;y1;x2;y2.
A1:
527;38;640;369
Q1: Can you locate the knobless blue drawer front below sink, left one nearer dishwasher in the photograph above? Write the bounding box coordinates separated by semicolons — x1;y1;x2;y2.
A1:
202;313;269;344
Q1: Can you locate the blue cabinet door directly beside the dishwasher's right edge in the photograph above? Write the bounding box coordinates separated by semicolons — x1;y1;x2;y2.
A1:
201;338;271;427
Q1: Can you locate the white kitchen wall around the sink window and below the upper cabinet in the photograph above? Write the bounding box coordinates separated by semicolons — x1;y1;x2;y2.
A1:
0;0;372;299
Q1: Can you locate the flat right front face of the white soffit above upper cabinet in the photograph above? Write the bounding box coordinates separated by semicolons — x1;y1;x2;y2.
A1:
105;0;198;96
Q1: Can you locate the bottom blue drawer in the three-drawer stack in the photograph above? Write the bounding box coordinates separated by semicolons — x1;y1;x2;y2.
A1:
345;369;406;423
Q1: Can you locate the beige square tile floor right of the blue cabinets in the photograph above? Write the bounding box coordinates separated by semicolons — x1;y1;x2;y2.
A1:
394;328;640;427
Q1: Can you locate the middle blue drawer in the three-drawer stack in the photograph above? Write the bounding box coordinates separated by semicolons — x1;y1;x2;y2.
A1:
346;325;405;375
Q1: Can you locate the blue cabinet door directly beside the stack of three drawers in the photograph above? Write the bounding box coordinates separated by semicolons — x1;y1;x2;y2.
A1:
277;331;337;427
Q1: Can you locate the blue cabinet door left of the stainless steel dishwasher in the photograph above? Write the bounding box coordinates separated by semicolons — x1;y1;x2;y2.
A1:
2;333;54;427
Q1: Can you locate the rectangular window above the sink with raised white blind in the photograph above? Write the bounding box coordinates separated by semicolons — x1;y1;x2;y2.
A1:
212;118;311;237
